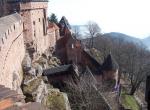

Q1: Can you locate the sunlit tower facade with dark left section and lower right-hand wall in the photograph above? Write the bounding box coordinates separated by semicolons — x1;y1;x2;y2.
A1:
1;0;59;54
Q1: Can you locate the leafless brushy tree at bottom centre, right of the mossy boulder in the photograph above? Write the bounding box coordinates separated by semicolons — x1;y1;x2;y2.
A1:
62;67;109;110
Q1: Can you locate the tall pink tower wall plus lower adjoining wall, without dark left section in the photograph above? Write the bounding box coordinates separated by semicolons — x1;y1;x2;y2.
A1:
20;2;59;54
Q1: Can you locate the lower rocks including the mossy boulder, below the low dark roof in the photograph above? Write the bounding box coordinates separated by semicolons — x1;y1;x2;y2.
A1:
23;76;71;110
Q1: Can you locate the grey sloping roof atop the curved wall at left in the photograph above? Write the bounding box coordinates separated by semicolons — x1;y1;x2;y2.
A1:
0;13;21;38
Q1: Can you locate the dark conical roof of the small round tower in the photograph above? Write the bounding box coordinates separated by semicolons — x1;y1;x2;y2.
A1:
102;54;119;71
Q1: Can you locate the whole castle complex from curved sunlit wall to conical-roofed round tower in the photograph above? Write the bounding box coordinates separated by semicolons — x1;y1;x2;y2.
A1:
0;0;118;109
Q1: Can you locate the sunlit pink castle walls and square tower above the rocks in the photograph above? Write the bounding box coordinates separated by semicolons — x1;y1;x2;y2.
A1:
0;0;59;88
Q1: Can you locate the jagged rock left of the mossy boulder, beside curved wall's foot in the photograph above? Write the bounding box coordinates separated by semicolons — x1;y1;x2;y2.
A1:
23;76;47;103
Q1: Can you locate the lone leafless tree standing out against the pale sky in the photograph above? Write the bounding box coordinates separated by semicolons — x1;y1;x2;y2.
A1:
87;21;101;48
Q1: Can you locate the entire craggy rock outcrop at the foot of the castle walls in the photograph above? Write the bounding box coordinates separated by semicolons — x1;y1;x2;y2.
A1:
21;50;71;110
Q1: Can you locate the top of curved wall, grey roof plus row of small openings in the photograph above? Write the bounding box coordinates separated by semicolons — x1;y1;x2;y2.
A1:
0;13;22;51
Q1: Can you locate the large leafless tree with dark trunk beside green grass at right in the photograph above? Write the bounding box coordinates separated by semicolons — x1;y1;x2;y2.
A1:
124;43;150;95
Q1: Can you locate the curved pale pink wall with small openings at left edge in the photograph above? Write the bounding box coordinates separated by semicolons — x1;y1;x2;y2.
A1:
0;13;25;90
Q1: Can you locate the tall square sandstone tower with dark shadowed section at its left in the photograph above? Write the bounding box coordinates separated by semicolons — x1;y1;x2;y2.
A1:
7;0;48;53
